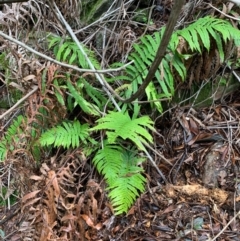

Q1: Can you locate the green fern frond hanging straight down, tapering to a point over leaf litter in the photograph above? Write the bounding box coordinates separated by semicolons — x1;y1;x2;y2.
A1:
93;145;146;215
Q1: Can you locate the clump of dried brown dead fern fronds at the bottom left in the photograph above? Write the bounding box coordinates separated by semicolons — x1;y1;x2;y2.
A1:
20;152;108;241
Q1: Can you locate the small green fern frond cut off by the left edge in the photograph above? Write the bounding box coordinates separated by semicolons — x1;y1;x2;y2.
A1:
0;115;24;161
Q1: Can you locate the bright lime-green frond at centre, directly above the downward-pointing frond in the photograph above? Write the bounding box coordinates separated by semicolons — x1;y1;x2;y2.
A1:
91;111;154;150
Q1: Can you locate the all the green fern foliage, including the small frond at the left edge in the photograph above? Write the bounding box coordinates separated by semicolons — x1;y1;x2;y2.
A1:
0;17;240;214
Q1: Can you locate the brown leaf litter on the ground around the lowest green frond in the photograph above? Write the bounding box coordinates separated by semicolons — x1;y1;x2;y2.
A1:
0;91;240;241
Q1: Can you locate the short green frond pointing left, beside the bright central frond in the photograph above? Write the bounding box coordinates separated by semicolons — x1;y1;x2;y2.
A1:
40;121;89;148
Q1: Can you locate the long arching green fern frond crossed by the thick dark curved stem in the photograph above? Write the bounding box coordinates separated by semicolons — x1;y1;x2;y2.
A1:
114;16;240;112
